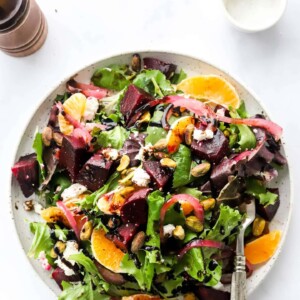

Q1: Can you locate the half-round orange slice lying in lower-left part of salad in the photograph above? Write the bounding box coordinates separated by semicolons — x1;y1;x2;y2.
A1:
91;229;125;273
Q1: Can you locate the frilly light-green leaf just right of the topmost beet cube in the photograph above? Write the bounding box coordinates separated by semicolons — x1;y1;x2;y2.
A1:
133;70;175;98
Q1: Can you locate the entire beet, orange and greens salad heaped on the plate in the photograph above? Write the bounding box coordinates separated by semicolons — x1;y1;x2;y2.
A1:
12;54;286;300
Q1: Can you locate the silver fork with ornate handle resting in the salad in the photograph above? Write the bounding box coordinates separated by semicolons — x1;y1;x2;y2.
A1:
230;199;255;300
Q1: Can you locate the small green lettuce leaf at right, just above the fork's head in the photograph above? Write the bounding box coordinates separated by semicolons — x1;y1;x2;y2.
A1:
246;178;278;206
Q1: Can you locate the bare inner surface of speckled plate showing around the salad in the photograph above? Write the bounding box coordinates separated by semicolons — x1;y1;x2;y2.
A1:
11;52;292;295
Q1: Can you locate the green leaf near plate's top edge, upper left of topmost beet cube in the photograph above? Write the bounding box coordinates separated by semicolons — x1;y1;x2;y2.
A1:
91;65;130;91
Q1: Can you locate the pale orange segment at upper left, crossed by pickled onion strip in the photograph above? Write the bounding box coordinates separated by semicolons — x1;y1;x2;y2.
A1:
58;93;86;135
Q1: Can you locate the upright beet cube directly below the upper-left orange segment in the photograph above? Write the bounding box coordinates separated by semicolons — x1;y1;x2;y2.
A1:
59;136;90;181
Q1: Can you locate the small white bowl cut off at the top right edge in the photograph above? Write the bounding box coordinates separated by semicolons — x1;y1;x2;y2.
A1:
222;0;287;32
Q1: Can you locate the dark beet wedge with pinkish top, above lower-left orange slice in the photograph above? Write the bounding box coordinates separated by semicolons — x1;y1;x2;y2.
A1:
121;188;150;225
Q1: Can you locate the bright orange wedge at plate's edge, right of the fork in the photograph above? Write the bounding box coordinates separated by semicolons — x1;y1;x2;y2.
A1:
245;230;281;265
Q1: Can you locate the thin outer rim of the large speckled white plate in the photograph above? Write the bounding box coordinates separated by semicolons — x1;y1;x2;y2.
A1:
8;49;294;296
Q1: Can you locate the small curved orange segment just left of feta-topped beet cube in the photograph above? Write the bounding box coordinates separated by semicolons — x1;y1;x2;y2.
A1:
167;116;194;153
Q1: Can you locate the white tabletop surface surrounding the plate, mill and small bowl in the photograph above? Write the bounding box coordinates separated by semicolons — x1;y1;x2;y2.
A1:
0;0;300;300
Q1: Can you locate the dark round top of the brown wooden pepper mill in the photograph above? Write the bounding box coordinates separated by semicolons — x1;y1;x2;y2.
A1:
0;0;28;31
